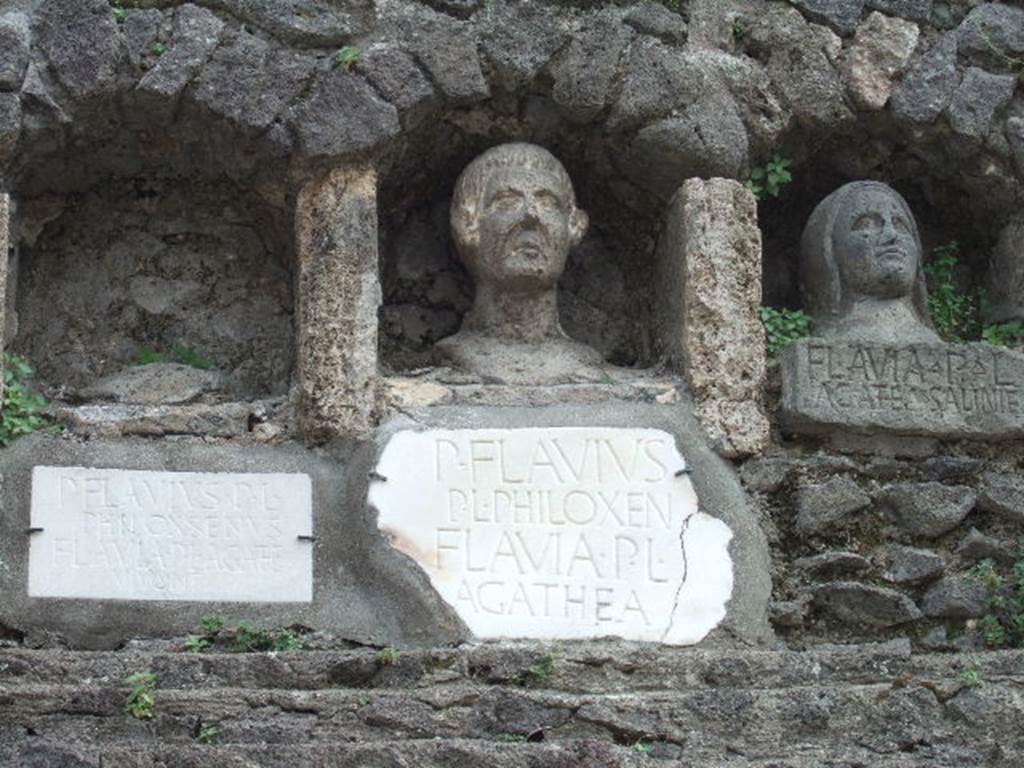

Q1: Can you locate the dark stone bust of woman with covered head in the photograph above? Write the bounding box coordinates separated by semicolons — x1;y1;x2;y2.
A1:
800;181;940;344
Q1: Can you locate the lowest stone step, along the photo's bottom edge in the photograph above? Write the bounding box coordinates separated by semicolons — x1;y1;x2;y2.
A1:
0;734;1020;768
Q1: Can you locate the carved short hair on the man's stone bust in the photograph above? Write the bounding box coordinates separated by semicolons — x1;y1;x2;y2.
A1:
452;142;586;256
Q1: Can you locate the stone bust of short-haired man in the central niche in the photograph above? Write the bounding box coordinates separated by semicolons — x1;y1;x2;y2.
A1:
437;143;602;384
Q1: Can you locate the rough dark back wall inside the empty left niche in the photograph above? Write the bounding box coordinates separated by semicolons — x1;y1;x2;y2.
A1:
10;180;293;399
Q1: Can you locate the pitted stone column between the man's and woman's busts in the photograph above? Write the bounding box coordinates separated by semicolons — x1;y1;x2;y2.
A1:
655;178;768;458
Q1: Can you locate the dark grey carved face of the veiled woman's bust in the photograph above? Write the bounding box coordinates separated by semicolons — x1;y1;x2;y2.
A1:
833;189;921;299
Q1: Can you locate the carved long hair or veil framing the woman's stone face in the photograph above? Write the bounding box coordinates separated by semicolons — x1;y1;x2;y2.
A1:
800;181;932;333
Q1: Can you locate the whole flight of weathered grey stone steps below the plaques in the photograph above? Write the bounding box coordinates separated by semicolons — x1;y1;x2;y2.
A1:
0;642;1024;768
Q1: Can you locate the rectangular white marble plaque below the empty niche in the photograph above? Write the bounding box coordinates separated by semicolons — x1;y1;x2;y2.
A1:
29;467;312;602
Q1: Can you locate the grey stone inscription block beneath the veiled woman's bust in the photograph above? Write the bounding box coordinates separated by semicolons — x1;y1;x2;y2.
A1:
782;339;1024;438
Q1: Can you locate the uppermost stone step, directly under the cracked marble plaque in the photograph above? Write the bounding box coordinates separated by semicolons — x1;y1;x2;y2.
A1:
0;641;1024;693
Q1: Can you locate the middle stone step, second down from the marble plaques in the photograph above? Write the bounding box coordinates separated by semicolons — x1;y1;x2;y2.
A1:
0;679;1024;752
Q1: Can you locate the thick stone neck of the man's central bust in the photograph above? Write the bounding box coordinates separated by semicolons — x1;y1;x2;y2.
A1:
462;284;565;342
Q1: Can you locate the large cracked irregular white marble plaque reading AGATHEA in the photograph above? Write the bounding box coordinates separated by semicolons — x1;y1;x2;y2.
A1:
370;427;732;645
